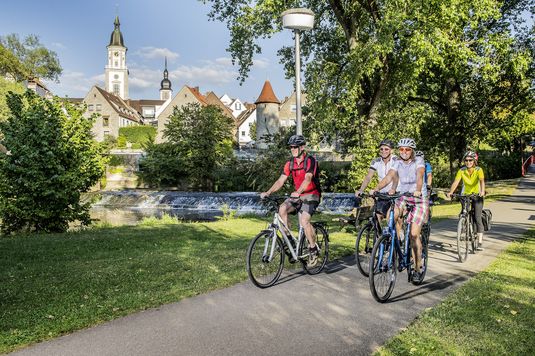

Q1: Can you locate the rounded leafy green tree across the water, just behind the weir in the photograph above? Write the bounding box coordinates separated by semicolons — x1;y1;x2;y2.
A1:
164;104;234;190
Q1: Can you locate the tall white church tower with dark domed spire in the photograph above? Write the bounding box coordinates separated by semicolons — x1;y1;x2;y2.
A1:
105;16;128;99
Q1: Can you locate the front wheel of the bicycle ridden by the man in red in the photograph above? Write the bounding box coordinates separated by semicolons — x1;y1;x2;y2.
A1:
247;230;284;288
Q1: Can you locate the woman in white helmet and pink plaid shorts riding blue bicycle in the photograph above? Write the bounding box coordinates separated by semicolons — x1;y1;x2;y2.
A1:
376;138;429;281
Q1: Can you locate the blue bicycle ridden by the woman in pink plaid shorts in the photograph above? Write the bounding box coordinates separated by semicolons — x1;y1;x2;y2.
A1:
368;193;429;303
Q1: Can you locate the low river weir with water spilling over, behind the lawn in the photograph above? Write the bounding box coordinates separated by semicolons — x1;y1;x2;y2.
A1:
89;190;354;224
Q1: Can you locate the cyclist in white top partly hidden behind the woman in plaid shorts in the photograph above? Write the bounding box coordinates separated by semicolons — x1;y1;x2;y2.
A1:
355;139;397;222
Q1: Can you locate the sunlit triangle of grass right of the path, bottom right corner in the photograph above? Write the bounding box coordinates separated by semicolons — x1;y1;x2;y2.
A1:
377;229;535;355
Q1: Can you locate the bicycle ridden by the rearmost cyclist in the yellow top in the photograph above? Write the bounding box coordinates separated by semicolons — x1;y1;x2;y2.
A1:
451;194;479;262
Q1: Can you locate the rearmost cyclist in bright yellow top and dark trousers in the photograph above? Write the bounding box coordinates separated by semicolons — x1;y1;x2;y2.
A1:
446;151;485;251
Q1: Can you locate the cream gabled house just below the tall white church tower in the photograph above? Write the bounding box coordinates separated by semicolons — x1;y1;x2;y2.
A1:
83;85;143;142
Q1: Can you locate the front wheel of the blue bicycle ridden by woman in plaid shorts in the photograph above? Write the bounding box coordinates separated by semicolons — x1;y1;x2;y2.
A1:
368;235;397;303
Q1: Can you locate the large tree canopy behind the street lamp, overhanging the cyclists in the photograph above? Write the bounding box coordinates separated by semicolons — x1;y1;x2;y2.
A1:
203;0;534;178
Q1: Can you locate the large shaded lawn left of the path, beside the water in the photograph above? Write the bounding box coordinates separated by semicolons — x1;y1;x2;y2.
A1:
0;213;354;353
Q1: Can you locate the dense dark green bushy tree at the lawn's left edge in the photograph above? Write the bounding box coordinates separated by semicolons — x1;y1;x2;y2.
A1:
0;90;105;233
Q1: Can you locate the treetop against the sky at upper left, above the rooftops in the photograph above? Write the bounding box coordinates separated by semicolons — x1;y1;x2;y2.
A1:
0;33;63;82
